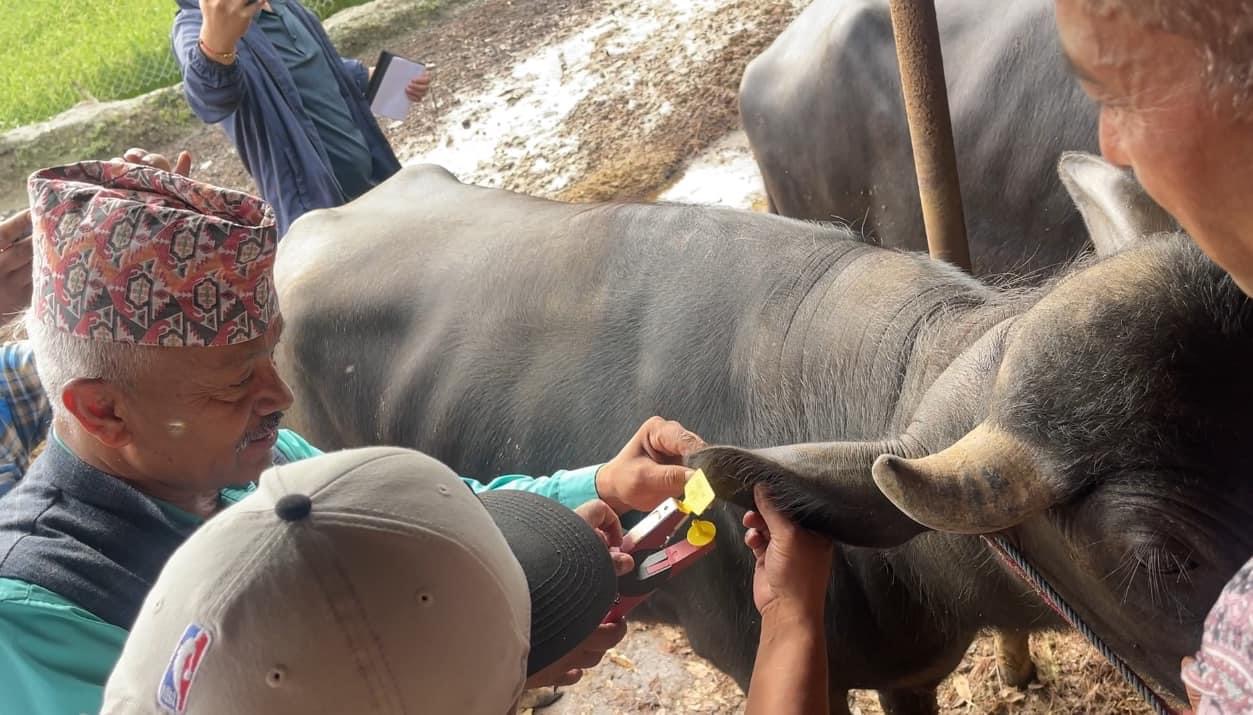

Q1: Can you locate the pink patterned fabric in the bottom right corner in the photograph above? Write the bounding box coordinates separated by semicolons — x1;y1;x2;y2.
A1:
1183;558;1253;715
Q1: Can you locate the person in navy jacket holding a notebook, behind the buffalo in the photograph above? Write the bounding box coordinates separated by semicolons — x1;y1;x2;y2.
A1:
172;0;430;235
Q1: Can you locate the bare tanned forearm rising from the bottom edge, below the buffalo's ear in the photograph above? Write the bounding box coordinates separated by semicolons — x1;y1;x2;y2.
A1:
746;602;829;715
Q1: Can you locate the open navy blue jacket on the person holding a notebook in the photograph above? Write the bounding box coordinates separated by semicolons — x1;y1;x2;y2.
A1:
170;0;400;235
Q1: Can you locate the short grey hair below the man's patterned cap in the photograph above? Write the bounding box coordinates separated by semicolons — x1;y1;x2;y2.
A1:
24;311;152;414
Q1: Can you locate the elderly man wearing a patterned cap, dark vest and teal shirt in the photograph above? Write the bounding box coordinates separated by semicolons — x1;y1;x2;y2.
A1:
0;162;702;714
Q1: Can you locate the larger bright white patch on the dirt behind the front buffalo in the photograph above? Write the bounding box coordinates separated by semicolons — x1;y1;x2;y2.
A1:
396;0;732;194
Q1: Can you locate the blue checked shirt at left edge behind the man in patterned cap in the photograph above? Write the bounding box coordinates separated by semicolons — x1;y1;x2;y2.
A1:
0;342;53;496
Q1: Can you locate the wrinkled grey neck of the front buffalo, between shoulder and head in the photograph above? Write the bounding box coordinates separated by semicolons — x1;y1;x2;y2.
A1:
779;244;1037;441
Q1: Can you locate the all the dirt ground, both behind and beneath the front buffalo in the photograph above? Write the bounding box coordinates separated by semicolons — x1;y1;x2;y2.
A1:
146;0;1172;715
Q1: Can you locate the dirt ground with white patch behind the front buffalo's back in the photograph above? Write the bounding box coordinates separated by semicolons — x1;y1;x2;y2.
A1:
163;0;801;200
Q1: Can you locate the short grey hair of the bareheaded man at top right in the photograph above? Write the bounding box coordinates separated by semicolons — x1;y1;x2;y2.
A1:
1085;0;1253;115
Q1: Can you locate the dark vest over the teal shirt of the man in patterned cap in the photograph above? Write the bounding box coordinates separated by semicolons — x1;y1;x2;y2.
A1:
0;440;282;631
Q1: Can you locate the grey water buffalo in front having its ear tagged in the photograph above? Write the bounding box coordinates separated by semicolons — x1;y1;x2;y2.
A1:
276;157;1253;712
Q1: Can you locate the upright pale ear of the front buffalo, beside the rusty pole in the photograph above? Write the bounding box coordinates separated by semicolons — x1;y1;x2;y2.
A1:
1058;152;1179;257
